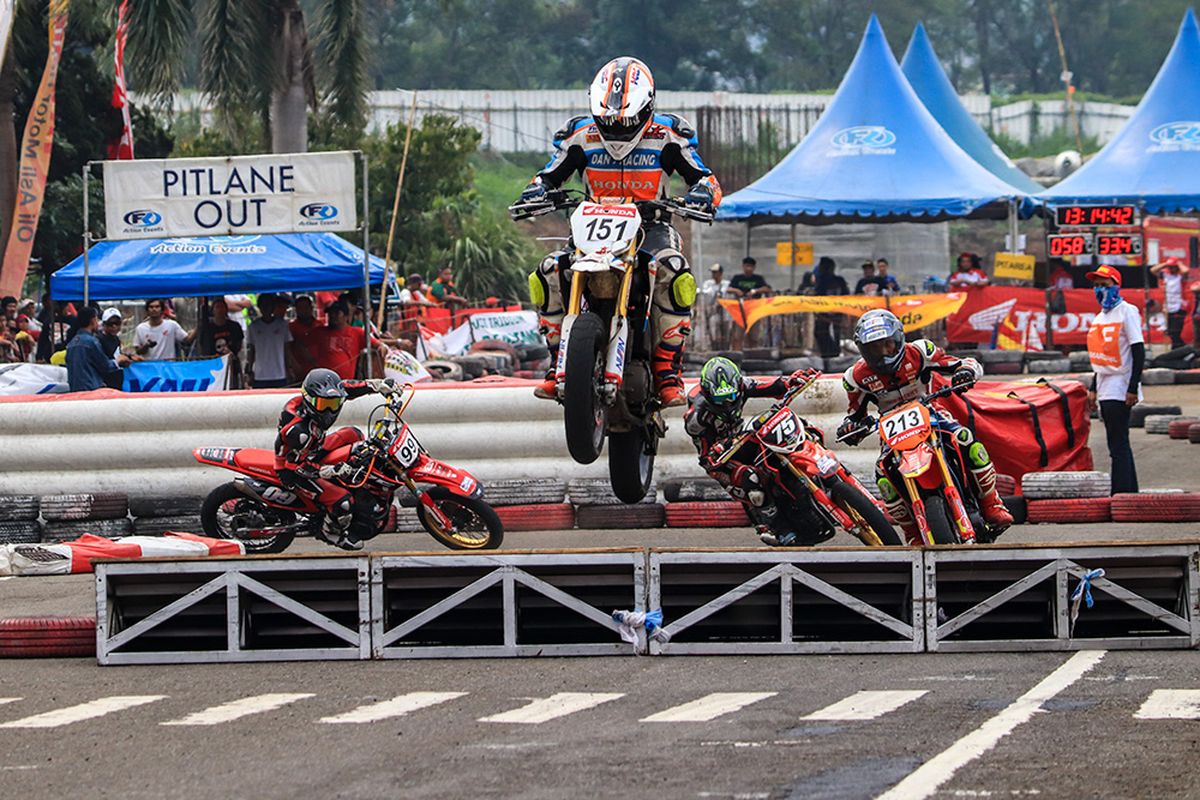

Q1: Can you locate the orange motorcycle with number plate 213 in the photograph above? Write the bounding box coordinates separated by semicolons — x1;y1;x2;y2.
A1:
839;386;1003;545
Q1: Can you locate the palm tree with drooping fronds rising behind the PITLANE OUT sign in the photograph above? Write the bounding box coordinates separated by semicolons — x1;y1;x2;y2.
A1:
126;0;367;152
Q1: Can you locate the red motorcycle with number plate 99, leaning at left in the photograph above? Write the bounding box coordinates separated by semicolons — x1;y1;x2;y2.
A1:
192;386;504;553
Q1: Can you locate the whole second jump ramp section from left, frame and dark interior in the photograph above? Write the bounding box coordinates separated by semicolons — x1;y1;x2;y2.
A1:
371;548;646;658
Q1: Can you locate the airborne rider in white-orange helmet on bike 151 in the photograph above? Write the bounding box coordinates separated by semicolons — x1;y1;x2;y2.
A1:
521;56;721;405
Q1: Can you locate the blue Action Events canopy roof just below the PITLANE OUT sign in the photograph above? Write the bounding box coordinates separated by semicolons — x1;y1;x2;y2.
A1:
50;233;385;300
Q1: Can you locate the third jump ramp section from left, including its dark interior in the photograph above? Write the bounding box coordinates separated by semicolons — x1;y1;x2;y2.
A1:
648;548;925;655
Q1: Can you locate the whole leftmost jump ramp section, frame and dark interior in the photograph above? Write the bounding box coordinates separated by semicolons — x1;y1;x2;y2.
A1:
95;557;371;664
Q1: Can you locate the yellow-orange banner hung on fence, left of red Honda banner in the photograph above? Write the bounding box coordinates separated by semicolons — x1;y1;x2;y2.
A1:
721;291;967;331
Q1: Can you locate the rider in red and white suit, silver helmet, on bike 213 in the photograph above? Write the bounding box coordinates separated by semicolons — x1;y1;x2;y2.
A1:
838;308;1013;543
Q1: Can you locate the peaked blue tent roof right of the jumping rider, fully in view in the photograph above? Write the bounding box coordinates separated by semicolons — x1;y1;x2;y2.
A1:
718;14;1033;225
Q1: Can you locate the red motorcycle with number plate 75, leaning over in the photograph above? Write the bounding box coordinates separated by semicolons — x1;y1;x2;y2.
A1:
709;373;901;547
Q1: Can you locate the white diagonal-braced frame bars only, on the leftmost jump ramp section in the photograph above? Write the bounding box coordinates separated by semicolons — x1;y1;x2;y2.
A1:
95;557;371;664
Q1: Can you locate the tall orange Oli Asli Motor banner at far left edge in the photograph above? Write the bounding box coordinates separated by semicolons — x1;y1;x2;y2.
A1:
0;0;71;295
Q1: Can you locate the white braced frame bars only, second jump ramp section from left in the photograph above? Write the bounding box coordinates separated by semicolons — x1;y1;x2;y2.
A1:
371;548;646;658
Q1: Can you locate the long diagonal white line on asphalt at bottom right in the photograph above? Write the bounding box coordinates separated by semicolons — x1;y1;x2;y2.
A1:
878;650;1104;800
